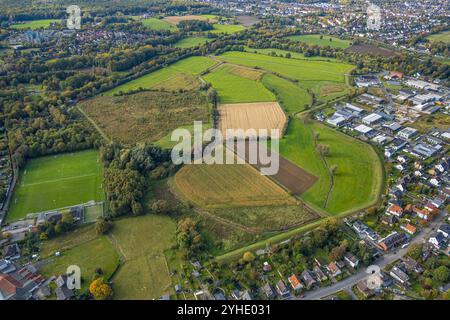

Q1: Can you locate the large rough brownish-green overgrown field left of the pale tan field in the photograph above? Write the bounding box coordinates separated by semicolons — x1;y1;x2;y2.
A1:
80;91;210;144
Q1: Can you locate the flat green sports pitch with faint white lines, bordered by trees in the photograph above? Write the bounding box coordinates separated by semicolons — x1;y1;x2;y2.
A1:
7;150;103;221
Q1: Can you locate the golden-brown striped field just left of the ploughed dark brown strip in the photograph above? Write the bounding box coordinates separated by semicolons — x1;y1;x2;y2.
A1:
174;164;296;208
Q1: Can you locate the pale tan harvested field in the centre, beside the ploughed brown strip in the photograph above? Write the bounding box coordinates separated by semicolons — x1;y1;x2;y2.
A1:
219;102;287;135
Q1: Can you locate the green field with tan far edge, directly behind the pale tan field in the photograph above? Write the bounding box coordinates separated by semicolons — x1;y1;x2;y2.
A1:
204;64;276;103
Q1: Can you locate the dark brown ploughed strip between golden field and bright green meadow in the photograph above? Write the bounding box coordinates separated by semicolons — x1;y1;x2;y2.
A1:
237;141;317;196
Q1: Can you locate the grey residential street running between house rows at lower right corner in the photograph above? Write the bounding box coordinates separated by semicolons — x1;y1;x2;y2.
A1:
293;211;447;300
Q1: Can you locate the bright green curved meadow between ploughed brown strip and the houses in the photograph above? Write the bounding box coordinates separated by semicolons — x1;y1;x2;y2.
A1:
280;119;383;215
